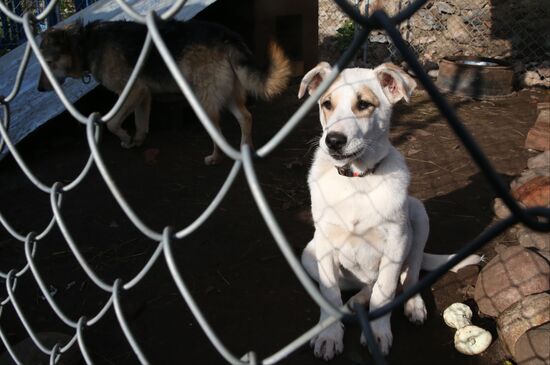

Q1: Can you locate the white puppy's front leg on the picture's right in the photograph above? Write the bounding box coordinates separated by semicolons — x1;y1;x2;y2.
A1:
361;223;409;355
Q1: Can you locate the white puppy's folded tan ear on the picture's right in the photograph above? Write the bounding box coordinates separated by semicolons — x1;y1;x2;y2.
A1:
374;63;416;104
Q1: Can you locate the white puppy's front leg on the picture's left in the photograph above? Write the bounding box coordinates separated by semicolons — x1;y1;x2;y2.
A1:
311;229;344;360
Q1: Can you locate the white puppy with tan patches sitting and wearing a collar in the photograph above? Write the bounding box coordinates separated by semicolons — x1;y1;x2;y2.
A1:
298;62;480;360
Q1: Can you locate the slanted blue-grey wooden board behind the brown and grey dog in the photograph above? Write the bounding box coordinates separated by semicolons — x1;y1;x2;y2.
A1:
0;0;220;160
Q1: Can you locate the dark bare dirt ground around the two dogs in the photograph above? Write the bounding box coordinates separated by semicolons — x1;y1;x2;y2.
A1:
0;80;548;365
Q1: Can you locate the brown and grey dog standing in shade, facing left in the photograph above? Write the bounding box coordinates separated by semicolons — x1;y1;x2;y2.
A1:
38;21;291;165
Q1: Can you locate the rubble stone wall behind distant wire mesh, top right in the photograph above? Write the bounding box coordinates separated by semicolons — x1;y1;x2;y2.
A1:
319;0;550;87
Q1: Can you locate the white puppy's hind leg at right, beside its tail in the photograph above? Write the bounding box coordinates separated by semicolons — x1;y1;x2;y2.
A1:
400;197;429;324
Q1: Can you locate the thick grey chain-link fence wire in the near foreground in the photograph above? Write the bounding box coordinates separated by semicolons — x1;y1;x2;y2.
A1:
0;0;550;364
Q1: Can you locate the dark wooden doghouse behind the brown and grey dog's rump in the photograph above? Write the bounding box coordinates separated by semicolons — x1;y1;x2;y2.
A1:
196;0;318;76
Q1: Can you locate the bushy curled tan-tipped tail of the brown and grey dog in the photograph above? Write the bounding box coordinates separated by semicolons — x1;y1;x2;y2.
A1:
232;42;291;100
